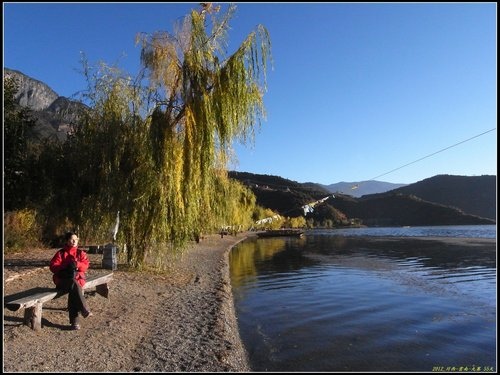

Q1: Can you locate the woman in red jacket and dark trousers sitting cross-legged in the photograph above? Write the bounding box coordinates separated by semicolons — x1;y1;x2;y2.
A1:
50;232;92;330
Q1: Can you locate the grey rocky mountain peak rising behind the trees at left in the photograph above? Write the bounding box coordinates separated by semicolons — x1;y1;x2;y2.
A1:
3;68;86;141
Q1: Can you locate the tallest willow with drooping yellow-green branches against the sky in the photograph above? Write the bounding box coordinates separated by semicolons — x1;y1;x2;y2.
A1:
133;4;270;253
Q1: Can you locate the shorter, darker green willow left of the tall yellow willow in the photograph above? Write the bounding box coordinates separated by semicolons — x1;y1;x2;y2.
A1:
64;61;154;266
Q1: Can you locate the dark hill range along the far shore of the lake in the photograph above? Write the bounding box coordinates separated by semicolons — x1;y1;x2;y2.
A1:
229;172;496;226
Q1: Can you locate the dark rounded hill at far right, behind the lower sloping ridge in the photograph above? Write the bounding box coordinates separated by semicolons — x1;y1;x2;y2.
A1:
370;175;497;220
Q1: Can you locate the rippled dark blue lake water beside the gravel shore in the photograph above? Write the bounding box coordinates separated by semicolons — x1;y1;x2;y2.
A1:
230;225;497;372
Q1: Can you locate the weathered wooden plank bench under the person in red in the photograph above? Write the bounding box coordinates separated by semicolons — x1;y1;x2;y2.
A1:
4;273;113;331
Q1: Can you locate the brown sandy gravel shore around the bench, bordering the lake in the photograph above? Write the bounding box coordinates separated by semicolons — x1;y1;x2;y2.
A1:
3;234;254;373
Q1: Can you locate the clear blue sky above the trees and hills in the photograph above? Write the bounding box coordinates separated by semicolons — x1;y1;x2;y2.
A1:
3;3;497;184
